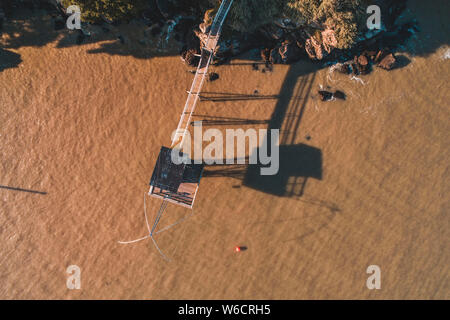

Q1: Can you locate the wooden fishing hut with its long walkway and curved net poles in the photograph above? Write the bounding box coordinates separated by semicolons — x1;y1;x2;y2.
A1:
119;0;233;260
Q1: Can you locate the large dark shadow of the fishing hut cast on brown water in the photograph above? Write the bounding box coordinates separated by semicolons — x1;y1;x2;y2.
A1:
204;63;322;197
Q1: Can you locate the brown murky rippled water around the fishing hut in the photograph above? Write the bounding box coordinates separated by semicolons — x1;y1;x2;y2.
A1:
0;1;450;299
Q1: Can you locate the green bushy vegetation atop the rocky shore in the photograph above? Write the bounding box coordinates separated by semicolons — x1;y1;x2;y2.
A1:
62;0;367;49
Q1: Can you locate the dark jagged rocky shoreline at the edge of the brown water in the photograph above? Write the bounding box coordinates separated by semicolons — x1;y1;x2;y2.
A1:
0;0;418;75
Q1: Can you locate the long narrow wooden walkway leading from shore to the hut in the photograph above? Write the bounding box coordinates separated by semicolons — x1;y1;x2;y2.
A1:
171;0;233;149
